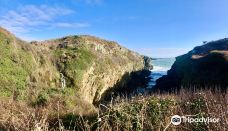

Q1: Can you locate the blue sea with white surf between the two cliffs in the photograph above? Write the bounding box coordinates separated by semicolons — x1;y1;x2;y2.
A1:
147;58;175;89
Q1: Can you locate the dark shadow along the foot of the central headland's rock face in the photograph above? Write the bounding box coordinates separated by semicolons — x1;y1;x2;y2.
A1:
93;69;151;105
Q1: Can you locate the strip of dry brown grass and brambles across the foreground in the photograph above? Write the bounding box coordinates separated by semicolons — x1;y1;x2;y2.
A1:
0;90;228;131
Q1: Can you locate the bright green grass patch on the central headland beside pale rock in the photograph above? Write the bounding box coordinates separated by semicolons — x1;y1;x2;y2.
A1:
54;46;96;88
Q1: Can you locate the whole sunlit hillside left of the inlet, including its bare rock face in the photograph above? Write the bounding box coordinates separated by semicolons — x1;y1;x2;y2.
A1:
0;28;145;110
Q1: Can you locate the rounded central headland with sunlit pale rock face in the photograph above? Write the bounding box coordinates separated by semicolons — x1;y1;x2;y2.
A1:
44;36;144;103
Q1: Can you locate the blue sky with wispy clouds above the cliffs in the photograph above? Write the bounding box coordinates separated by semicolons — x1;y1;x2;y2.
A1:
0;0;228;57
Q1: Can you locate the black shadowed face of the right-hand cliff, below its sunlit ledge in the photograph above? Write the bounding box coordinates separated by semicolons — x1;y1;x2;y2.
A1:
154;53;228;93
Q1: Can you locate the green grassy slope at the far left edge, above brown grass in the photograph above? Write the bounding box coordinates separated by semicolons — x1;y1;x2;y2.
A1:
0;33;33;99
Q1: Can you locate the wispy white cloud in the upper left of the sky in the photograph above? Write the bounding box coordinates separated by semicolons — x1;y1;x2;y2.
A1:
0;5;88;35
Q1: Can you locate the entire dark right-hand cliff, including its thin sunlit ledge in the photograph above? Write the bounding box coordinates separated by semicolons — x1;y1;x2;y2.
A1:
155;39;228;91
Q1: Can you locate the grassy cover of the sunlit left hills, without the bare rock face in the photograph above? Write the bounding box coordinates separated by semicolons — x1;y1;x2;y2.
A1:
0;28;142;113
